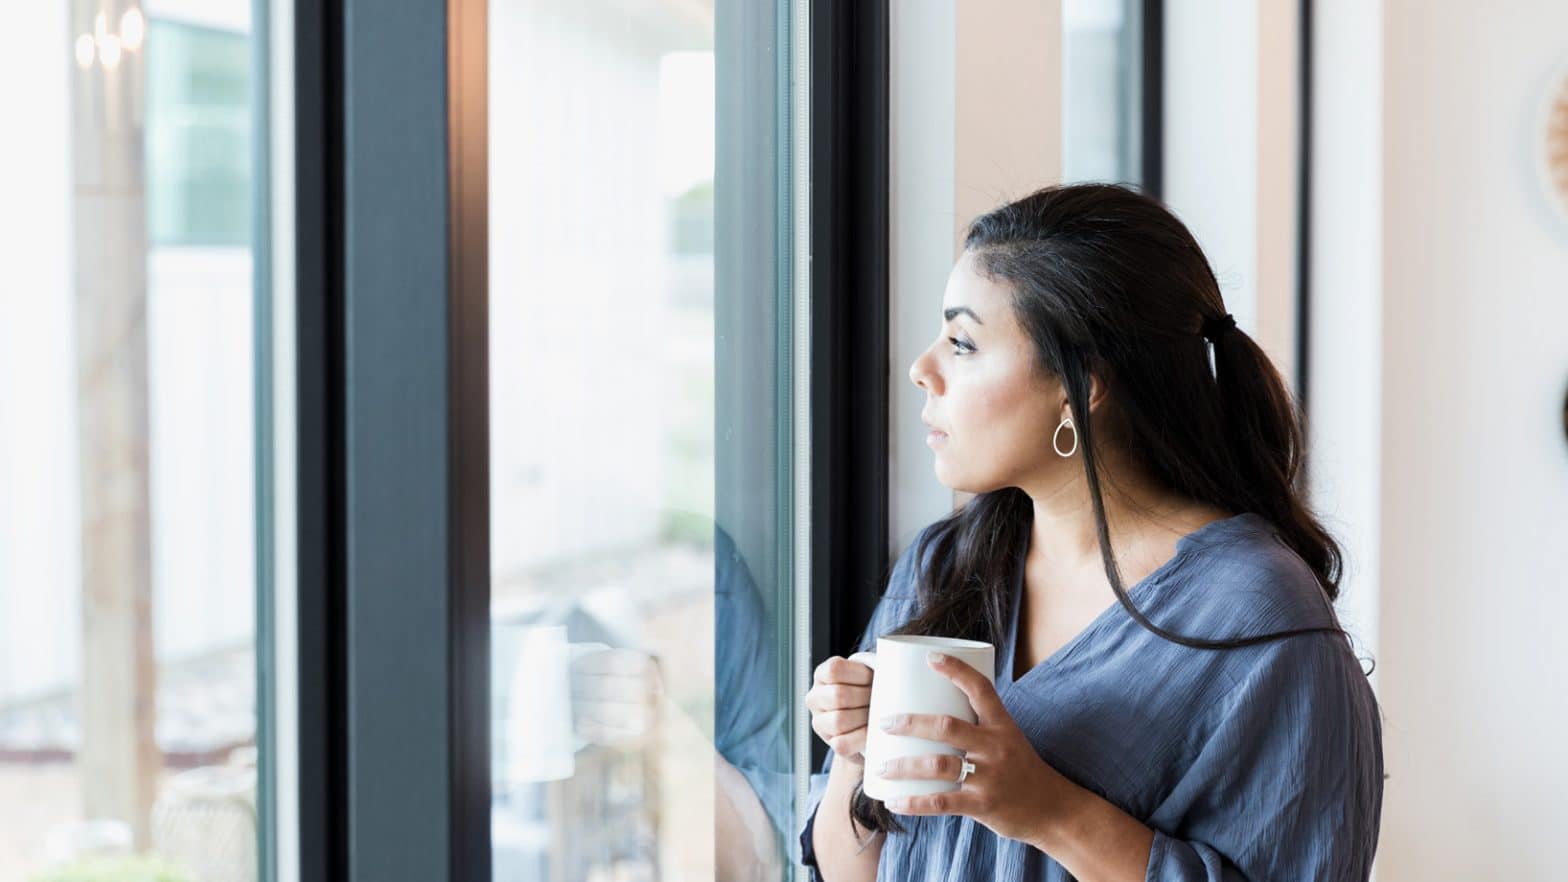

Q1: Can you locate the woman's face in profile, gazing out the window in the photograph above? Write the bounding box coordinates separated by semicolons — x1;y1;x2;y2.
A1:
909;251;1082;493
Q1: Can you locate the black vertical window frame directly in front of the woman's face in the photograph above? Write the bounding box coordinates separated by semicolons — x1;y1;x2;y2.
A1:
811;0;891;767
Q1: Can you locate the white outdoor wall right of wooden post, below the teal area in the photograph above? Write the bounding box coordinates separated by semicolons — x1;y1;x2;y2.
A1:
148;246;256;661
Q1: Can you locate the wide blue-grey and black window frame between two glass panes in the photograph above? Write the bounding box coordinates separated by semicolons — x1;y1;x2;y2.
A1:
293;0;491;882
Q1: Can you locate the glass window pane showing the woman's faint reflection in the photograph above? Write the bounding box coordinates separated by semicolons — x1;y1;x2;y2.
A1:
489;0;795;882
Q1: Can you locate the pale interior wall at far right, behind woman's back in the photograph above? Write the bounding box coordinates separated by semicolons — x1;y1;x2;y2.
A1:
1312;0;1568;880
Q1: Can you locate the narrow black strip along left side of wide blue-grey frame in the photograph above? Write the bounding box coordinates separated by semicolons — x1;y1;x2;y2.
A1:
292;0;348;882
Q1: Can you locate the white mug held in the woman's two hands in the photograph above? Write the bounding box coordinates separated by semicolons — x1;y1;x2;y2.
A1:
850;636;996;800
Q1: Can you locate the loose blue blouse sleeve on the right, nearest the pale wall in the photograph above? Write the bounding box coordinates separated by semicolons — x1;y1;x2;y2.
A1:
1146;632;1383;882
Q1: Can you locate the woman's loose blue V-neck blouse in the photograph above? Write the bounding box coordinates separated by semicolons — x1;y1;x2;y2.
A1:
800;513;1383;882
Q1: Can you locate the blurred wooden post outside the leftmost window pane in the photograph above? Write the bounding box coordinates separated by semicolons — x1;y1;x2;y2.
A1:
67;0;160;847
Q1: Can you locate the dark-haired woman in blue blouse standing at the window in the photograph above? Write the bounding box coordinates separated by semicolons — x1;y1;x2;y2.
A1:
801;185;1383;882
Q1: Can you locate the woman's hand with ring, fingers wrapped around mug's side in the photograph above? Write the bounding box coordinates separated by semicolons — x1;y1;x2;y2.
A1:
878;653;1083;844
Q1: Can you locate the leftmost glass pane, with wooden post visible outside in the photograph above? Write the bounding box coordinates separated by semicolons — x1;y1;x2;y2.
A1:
0;0;275;882
